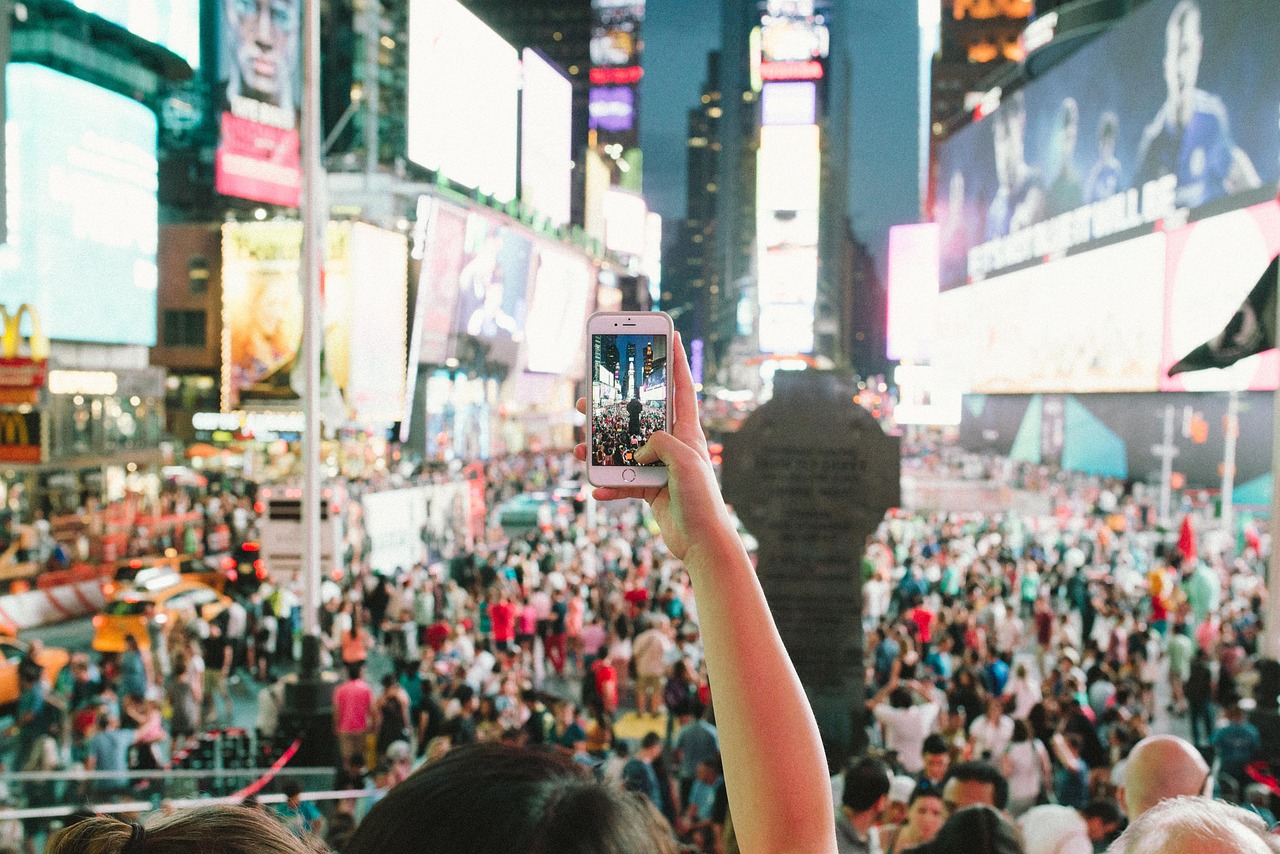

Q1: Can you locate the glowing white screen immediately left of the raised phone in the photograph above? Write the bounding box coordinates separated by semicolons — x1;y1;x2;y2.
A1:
525;242;595;379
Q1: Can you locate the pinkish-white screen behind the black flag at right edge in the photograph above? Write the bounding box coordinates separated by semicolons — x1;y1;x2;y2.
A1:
1160;201;1280;392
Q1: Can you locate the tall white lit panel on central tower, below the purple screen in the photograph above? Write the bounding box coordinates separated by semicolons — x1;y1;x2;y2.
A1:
755;124;822;353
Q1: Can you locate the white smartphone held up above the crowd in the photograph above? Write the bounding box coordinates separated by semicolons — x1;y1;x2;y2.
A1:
586;311;675;487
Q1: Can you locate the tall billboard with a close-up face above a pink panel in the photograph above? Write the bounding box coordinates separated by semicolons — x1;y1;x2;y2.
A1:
214;0;302;207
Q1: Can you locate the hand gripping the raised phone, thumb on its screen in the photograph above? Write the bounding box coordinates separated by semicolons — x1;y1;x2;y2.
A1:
573;333;736;560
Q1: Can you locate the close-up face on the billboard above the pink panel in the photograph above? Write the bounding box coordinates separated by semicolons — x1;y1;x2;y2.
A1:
221;0;301;121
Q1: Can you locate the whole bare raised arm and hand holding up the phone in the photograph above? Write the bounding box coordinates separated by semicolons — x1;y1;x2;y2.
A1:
577;339;836;854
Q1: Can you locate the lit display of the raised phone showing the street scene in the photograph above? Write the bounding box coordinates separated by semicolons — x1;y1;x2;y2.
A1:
591;333;667;466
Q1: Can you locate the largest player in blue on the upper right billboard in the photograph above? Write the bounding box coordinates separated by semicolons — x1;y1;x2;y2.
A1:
1134;0;1262;207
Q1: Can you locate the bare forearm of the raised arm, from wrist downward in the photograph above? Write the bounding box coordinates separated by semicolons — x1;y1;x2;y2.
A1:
685;526;836;854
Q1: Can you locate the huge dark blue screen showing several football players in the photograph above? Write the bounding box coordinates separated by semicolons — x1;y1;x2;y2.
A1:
936;0;1280;289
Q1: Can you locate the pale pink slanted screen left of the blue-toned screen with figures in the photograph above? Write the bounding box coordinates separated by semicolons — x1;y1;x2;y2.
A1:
410;196;467;365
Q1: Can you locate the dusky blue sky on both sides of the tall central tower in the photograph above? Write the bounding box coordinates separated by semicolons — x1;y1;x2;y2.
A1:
640;0;919;273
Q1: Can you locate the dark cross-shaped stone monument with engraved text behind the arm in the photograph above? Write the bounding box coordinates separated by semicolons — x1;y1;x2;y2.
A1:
721;371;901;763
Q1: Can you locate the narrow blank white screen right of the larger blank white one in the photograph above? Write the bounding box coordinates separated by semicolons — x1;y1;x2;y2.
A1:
520;47;573;227
